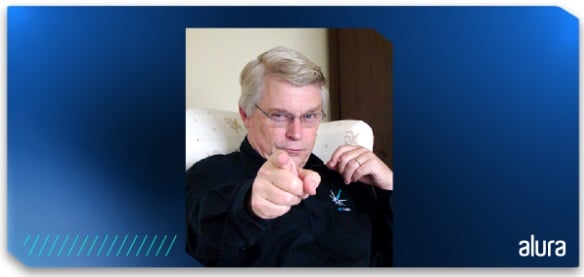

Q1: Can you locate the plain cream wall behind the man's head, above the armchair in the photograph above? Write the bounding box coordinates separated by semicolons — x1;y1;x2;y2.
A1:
186;28;330;117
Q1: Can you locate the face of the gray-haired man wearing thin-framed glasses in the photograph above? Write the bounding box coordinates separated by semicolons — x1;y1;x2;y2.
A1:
240;76;322;167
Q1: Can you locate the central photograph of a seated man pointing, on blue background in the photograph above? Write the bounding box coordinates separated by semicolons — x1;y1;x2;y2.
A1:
185;28;393;267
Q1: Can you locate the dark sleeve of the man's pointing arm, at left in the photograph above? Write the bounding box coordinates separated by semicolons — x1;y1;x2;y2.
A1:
186;156;270;266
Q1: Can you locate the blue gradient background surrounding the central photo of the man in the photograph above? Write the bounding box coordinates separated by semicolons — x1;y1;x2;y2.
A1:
7;7;579;267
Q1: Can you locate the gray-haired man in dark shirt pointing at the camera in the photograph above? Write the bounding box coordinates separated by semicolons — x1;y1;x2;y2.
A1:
186;47;393;267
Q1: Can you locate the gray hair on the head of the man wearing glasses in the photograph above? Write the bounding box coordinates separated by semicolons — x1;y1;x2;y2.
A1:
239;47;328;115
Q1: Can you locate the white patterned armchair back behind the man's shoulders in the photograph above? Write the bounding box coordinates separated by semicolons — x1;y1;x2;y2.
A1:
185;108;373;169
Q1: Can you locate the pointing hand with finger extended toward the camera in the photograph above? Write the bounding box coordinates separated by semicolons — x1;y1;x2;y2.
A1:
250;150;320;219
